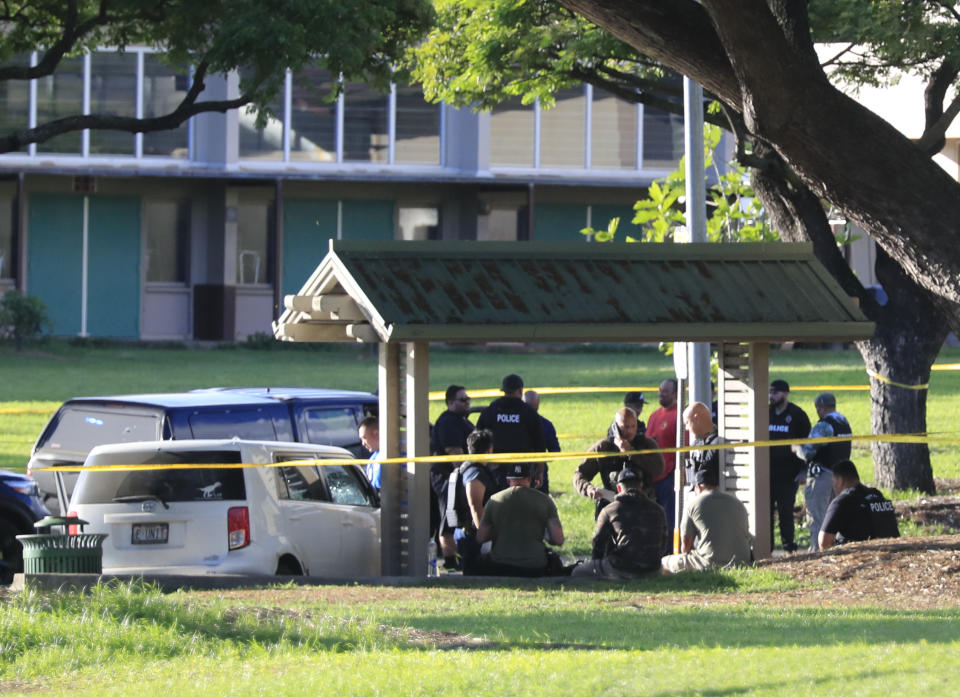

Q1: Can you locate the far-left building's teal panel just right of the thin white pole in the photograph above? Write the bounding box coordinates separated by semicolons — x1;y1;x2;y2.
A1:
87;196;141;339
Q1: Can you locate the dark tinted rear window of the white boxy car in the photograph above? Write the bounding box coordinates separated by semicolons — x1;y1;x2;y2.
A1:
75;450;247;504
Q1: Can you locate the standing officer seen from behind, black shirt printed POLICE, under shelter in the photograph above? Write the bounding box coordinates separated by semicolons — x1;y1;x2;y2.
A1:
477;373;547;489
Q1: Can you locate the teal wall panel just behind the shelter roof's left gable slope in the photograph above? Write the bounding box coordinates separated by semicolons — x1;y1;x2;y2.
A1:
281;198;337;295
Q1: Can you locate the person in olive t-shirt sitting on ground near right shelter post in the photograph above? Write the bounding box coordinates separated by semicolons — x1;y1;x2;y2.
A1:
660;468;753;574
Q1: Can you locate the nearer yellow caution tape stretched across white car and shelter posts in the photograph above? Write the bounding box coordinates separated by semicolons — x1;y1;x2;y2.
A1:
46;433;960;472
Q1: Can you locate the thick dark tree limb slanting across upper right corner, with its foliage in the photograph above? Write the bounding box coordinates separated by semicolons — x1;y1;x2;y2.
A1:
559;0;960;310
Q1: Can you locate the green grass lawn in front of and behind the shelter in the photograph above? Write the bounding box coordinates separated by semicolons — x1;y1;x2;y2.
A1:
0;343;960;697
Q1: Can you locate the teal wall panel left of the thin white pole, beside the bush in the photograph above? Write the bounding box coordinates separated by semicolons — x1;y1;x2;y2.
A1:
27;194;83;336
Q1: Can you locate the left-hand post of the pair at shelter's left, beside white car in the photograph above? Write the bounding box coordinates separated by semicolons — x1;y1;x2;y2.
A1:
377;344;405;576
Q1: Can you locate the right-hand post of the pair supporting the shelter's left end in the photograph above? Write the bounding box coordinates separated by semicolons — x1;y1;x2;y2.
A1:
404;341;430;576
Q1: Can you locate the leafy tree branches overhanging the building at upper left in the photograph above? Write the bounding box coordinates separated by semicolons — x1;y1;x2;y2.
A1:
0;0;433;152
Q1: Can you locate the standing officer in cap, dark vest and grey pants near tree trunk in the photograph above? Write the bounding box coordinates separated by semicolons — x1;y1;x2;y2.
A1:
803;392;853;552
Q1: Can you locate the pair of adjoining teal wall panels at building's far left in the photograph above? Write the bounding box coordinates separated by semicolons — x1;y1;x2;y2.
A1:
27;194;140;338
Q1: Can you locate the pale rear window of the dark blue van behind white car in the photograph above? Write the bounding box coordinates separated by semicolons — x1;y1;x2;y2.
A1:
40;407;161;456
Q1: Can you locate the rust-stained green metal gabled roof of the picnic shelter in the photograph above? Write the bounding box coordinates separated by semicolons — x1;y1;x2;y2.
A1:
275;242;874;342
